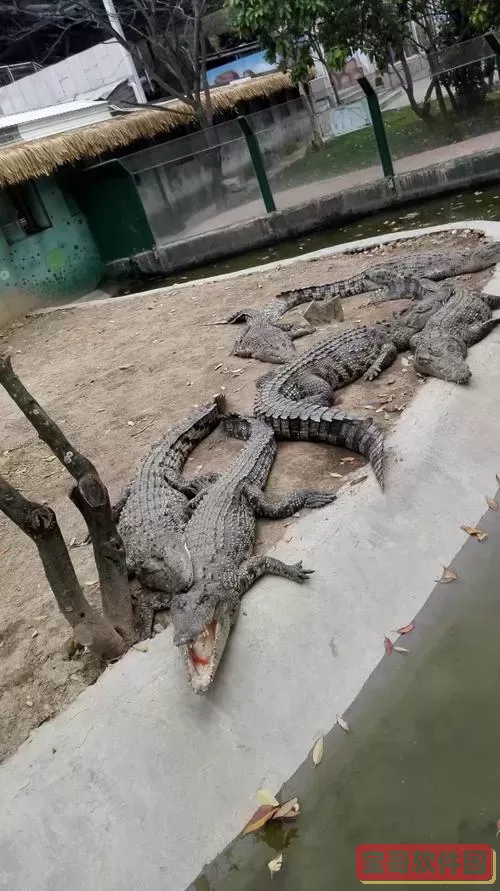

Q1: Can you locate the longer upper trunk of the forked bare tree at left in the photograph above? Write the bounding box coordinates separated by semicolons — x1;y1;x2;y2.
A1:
0;355;136;643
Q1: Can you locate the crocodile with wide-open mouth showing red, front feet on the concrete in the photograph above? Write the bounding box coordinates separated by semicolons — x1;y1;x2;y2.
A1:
170;415;335;693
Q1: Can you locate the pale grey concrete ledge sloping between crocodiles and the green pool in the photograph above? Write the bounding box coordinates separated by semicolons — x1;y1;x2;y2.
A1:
0;223;500;891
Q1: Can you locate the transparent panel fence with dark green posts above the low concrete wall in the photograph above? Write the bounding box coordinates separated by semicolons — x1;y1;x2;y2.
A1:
88;38;500;244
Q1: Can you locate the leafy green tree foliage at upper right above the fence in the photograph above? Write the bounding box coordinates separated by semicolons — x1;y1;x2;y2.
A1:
232;0;500;120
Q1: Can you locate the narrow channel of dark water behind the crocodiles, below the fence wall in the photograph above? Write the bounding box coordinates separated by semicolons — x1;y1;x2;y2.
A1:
117;185;500;293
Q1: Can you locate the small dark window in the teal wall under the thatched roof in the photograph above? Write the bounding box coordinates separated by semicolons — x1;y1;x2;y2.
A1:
0;183;52;244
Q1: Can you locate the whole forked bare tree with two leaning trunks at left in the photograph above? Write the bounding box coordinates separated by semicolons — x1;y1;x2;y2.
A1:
0;354;137;659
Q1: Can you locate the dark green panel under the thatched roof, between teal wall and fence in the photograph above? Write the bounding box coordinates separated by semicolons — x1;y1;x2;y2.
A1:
72;161;154;263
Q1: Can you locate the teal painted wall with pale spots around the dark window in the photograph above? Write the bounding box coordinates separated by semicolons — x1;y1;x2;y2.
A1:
0;177;103;302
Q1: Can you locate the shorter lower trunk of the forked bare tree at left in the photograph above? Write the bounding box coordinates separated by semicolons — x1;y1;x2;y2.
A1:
0;476;125;659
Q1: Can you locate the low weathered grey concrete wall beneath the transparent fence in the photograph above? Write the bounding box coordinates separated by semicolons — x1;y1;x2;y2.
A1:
106;149;500;278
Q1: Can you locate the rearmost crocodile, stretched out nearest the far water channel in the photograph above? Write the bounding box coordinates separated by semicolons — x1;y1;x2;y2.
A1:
276;242;500;306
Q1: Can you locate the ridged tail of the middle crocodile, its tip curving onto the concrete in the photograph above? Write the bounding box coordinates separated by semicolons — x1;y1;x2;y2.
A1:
256;398;384;489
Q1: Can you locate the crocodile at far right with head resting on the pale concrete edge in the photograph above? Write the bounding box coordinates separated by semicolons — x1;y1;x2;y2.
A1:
410;288;500;384
